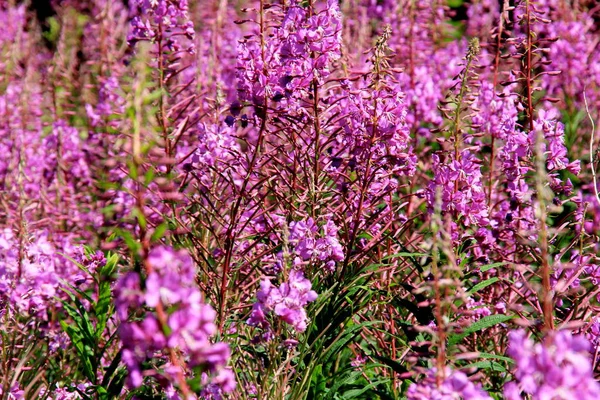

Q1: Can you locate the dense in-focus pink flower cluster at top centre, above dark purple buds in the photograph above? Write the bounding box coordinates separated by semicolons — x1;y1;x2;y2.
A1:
237;0;342;111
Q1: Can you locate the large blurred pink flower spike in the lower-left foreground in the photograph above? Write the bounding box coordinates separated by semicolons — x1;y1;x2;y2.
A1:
116;246;235;391
